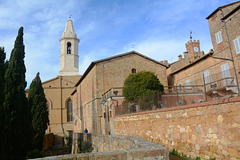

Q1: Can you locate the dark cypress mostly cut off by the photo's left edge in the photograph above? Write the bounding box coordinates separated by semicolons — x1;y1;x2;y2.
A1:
0;47;6;159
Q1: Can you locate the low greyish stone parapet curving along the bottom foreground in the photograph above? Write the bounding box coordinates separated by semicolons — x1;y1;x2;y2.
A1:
35;133;169;160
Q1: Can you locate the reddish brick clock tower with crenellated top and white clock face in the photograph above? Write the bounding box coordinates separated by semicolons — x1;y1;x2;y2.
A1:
185;40;201;63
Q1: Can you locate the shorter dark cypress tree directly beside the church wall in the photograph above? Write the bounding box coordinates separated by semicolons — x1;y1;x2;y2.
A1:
28;73;49;151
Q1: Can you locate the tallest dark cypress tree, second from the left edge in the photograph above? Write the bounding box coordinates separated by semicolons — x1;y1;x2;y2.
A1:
4;27;32;160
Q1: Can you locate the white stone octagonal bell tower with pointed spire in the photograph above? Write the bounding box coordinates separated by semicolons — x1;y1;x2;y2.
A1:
59;17;79;76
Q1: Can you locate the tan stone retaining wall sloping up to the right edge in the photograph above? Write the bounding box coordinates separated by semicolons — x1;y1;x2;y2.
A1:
115;97;240;160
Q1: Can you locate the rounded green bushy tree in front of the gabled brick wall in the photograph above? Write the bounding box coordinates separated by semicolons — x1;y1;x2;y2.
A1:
123;71;163;103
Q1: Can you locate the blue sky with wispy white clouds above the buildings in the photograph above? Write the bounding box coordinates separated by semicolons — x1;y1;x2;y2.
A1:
0;0;237;86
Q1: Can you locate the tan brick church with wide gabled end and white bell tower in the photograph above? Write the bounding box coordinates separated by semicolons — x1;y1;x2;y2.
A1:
42;18;167;144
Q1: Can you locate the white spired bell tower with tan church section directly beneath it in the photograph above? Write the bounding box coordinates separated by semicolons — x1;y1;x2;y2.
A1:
42;18;81;144
